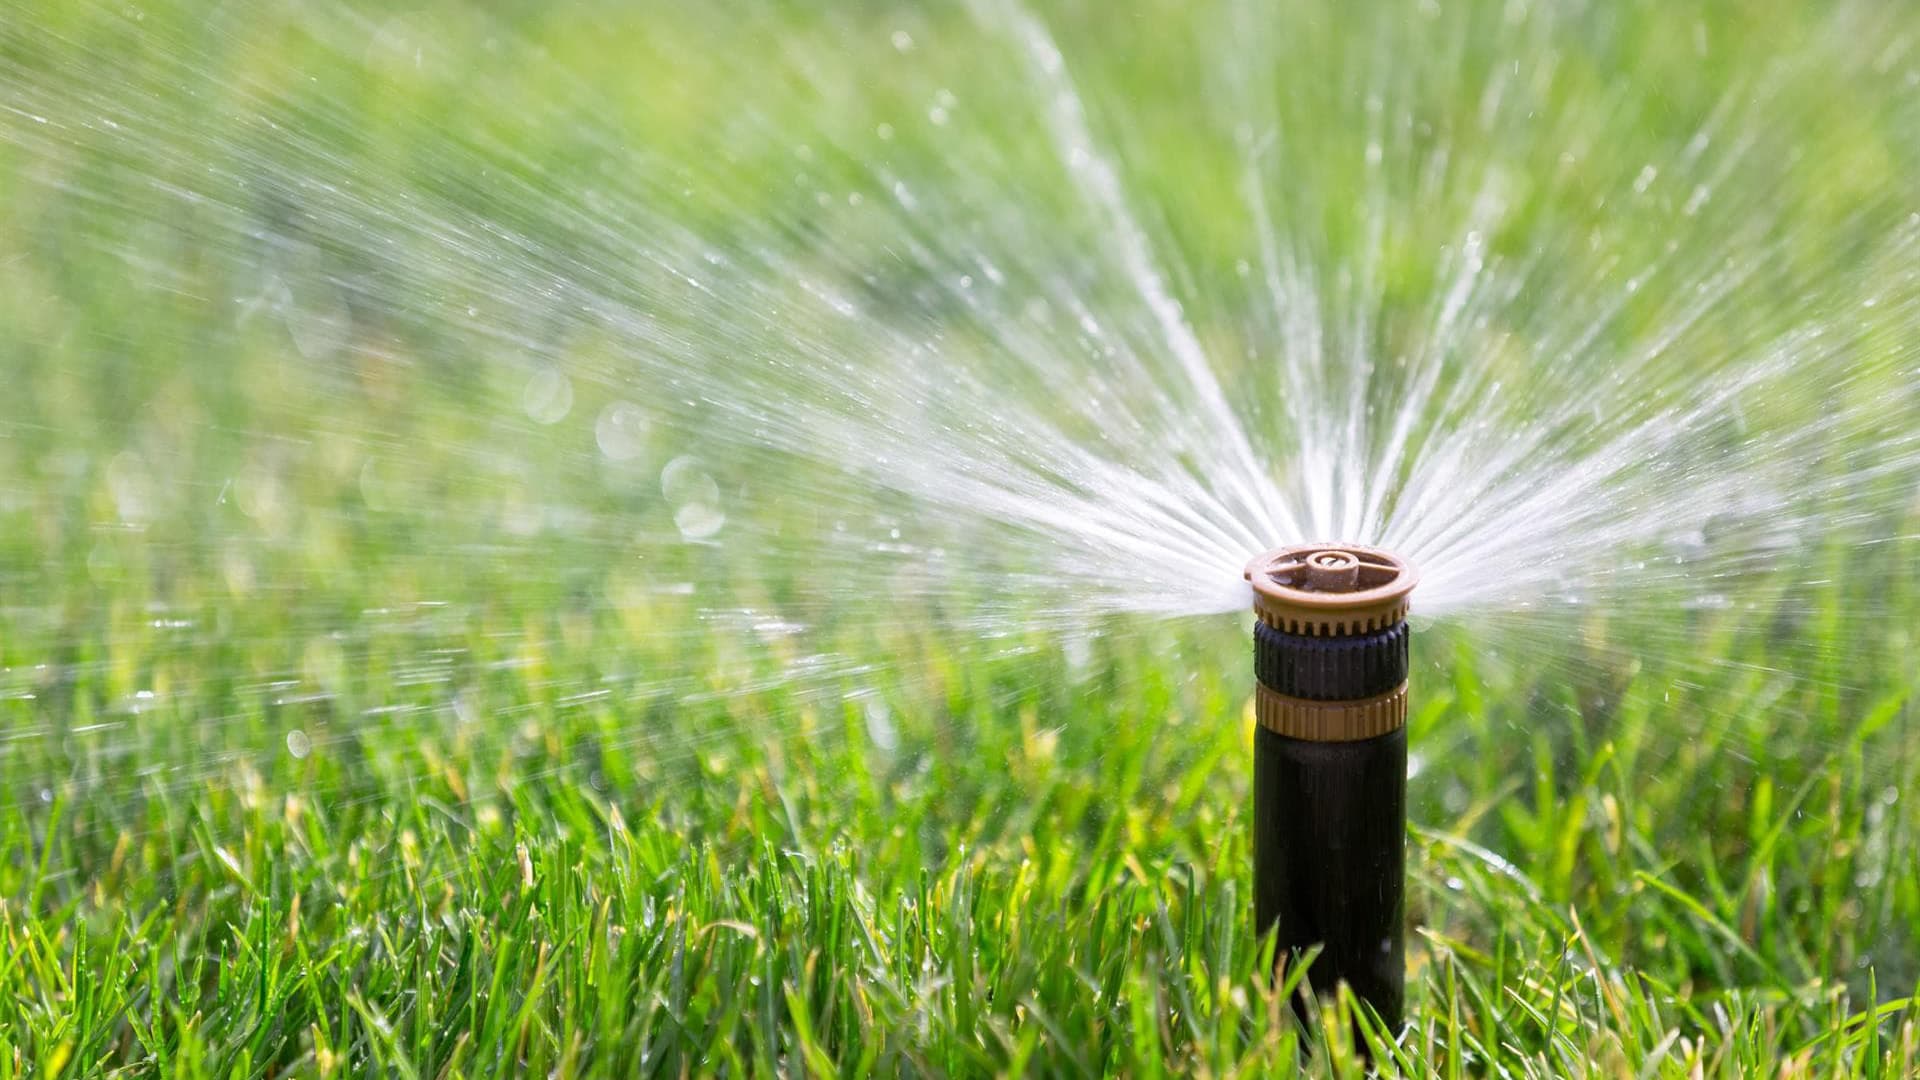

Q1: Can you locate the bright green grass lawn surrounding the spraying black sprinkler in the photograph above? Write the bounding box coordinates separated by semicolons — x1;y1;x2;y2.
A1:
0;0;1920;1078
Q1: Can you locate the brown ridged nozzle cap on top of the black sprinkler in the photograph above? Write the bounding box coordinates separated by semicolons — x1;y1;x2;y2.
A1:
1246;544;1421;638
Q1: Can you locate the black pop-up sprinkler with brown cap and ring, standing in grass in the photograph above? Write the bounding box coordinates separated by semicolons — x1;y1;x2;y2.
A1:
1246;544;1419;1032
